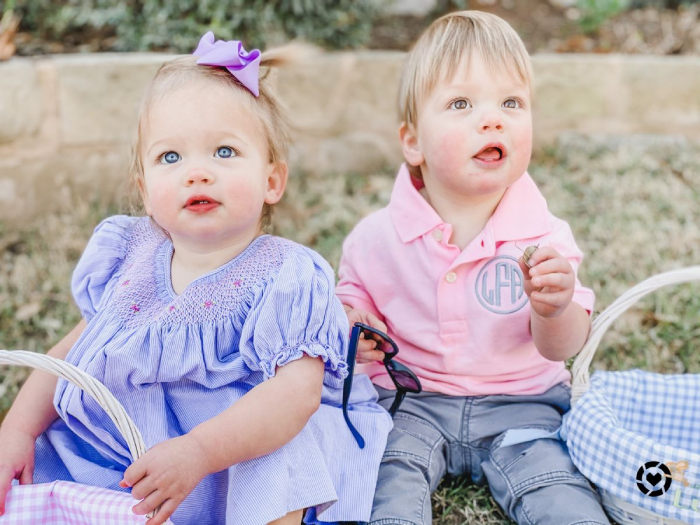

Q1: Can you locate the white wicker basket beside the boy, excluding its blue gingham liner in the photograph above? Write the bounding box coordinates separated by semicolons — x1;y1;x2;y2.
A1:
567;266;700;525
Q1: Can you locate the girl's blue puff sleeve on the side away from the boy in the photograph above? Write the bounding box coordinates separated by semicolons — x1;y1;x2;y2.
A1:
71;215;138;322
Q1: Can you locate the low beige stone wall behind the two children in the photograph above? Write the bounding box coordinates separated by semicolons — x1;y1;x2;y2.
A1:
0;51;700;224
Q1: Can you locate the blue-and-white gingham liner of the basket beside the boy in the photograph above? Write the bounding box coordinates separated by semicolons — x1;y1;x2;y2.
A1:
564;370;700;524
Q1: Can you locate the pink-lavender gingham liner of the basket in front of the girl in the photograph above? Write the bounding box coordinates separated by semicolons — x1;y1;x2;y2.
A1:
0;481;172;525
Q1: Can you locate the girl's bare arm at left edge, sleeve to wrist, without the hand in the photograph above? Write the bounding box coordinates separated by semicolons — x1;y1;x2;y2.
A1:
2;319;87;439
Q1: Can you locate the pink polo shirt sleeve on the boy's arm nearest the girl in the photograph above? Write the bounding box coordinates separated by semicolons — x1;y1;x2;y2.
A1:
335;228;384;321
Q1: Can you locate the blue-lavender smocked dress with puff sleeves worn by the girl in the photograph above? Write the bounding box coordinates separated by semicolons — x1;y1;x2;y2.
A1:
34;216;392;525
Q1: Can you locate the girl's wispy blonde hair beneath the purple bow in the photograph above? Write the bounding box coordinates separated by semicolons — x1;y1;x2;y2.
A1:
129;44;306;228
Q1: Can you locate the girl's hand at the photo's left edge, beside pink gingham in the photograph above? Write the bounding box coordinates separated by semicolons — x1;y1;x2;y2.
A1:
0;427;35;514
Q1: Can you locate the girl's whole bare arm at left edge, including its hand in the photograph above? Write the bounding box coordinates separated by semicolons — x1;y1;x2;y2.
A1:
0;319;87;515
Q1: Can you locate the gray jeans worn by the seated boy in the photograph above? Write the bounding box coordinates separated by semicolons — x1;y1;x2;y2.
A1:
370;384;609;525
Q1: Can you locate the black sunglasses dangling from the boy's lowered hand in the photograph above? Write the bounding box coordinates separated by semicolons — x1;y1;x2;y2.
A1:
343;323;423;448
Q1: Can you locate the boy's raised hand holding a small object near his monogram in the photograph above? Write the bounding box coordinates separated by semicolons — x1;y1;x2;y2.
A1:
518;246;576;317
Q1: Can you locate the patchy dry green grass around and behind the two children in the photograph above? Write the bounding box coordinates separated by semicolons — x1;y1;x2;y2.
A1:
0;137;700;525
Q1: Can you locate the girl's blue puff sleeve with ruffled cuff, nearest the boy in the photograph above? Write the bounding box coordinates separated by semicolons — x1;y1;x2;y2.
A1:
239;246;349;386
